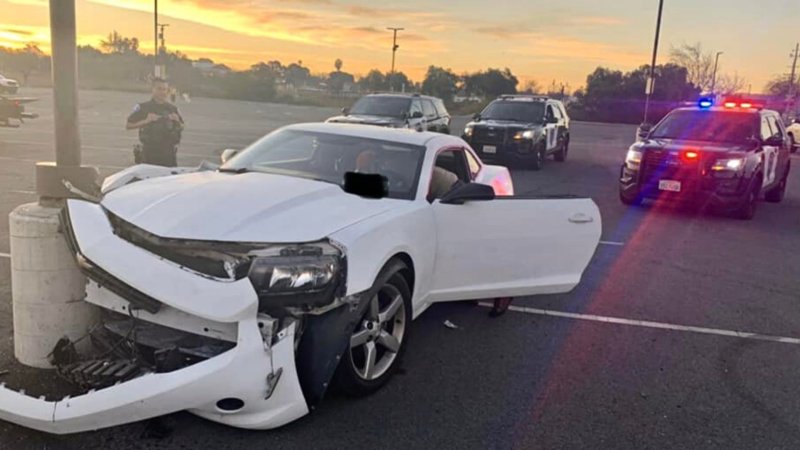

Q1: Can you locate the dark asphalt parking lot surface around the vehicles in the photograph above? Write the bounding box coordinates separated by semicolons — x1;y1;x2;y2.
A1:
0;91;800;449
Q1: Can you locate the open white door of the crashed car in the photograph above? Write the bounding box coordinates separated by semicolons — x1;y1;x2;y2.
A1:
431;190;602;302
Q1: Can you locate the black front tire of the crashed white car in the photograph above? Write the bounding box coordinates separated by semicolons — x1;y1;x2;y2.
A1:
334;260;411;397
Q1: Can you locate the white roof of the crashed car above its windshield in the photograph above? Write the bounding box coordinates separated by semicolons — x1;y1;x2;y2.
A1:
281;122;463;147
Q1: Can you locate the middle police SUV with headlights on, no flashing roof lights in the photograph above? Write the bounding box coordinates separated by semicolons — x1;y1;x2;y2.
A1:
461;95;570;170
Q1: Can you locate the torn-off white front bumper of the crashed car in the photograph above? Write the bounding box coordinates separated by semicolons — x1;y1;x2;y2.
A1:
0;200;363;434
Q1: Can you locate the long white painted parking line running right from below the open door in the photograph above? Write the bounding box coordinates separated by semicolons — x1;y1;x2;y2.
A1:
480;303;800;345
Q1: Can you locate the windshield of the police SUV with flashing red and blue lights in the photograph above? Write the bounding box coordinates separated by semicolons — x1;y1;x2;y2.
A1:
650;111;758;143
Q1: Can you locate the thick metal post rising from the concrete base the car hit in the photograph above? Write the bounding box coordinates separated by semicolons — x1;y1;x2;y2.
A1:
50;0;81;166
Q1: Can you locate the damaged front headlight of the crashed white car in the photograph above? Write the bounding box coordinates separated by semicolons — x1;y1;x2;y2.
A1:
248;243;344;307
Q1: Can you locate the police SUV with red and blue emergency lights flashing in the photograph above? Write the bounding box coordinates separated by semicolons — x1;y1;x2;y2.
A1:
619;100;791;220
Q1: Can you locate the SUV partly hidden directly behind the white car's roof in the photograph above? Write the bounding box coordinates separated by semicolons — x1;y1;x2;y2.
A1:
327;93;450;134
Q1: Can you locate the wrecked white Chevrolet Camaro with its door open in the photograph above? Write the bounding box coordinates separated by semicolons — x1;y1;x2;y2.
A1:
0;124;601;433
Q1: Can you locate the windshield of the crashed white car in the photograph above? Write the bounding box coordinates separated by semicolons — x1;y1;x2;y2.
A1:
220;130;425;200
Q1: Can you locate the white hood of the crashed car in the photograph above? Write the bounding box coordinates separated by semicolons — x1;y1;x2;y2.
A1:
102;172;401;243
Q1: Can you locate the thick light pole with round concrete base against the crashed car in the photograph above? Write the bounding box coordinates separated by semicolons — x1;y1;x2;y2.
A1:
9;0;99;368
